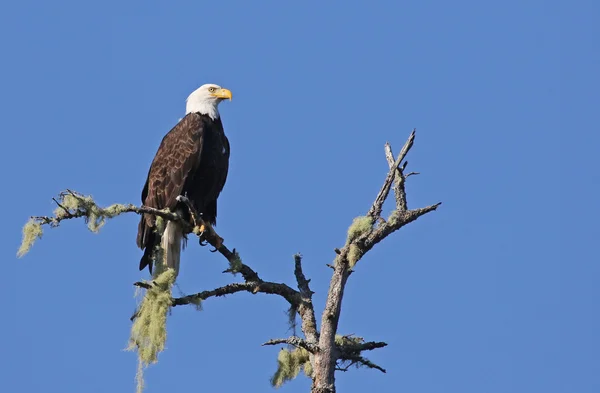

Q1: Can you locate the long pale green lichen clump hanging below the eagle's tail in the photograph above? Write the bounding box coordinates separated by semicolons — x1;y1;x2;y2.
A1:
127;269;176;393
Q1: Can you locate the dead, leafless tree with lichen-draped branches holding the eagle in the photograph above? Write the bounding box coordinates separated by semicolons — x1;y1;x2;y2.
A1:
18;130;441;393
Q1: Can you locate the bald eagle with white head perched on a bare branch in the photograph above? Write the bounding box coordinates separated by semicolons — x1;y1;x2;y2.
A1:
136;84;231;274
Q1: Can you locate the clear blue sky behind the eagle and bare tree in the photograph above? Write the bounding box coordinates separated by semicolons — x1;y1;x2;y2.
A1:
0;1;600;393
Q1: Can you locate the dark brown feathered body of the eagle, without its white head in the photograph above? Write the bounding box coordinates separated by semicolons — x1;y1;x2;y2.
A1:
137;112;229;272
